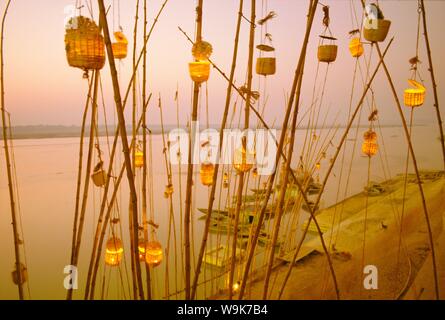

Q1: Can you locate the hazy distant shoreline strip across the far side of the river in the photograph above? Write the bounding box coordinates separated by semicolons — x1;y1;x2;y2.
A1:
0;124;426;140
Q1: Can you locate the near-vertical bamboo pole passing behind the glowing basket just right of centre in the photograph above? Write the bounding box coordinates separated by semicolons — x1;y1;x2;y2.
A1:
229;0;256;300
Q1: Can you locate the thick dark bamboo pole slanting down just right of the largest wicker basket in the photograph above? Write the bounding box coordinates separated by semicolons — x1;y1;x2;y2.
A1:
98;0;144;300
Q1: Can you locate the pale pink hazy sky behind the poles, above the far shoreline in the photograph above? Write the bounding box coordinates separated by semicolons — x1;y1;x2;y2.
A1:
1;0;445;129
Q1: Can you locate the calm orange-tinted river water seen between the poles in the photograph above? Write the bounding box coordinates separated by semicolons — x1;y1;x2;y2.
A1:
0;127;442;299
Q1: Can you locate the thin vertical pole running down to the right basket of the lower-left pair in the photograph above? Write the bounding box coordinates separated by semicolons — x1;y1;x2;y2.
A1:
141;0;151;300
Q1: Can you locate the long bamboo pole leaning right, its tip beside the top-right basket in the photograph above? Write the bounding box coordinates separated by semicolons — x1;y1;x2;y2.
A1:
278;38;394;299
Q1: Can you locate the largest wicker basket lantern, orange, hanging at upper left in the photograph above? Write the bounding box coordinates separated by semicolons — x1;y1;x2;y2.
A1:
65;16;105;71
